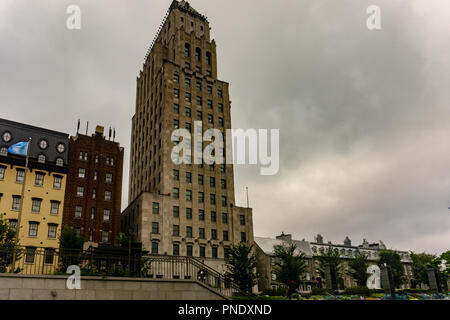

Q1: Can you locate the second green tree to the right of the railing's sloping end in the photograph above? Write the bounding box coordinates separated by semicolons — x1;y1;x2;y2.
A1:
274;244;307;296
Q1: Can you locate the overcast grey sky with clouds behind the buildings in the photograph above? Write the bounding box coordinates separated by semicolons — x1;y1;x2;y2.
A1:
0;0;450;253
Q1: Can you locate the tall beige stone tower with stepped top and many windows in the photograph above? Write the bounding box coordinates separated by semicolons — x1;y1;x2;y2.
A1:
122;1;253;271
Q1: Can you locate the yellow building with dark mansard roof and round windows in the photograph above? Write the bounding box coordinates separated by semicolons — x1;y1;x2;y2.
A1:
0;119;69;273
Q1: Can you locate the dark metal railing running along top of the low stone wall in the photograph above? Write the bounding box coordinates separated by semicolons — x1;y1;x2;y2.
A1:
0;247;243;297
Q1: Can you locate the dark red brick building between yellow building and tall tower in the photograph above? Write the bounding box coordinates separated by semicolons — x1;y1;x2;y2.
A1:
63;126;124;244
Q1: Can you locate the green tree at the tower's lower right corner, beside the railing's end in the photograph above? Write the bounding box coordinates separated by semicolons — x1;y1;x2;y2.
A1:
225;242;258;293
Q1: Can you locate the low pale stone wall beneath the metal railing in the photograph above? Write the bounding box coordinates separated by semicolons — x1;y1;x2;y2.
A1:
0;273;226;300
